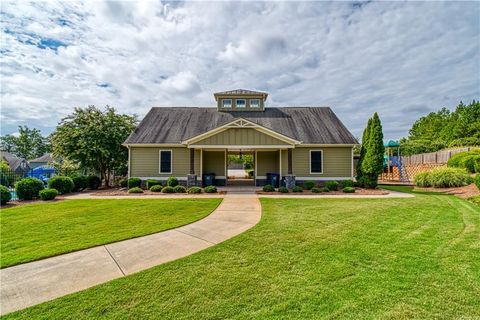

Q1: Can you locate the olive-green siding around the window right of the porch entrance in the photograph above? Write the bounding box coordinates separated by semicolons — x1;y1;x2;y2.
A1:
288;147;352;177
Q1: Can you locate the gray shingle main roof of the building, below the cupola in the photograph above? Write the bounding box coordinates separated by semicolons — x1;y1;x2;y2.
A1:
125;107;358;144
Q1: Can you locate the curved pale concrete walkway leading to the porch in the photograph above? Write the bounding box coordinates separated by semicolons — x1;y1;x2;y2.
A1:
0;194;261;315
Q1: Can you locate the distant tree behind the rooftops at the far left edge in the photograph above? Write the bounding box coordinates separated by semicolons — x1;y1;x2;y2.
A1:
0;126;51;160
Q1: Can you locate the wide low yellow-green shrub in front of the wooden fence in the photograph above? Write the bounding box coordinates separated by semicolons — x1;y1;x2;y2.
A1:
413;167;472;188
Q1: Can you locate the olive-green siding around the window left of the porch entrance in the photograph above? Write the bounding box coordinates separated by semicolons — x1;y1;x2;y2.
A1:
130;147;200;177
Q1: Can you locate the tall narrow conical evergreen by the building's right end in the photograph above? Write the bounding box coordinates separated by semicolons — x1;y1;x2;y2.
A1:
361;112;385;188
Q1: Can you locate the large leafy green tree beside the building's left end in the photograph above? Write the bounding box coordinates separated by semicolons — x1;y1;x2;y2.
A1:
52;106;137;186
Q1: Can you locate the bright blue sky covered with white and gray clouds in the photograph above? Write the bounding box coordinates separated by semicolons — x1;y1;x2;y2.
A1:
0;1;480;138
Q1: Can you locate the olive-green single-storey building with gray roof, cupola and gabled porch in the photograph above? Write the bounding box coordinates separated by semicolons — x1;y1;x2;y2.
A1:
124;89;358;187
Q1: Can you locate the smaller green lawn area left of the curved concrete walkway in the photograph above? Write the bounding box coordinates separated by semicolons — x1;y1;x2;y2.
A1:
0;199;221;268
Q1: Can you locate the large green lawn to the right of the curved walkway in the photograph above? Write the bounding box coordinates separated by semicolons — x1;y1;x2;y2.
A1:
5;189;480;319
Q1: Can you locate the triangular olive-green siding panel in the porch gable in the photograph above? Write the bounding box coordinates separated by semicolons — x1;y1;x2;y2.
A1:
192;128;288;146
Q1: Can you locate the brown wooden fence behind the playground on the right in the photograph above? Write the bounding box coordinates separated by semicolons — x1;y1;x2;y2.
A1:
380;147;473;183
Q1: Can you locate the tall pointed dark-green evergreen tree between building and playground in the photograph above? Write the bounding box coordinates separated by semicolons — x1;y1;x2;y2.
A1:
357;112;385;188
